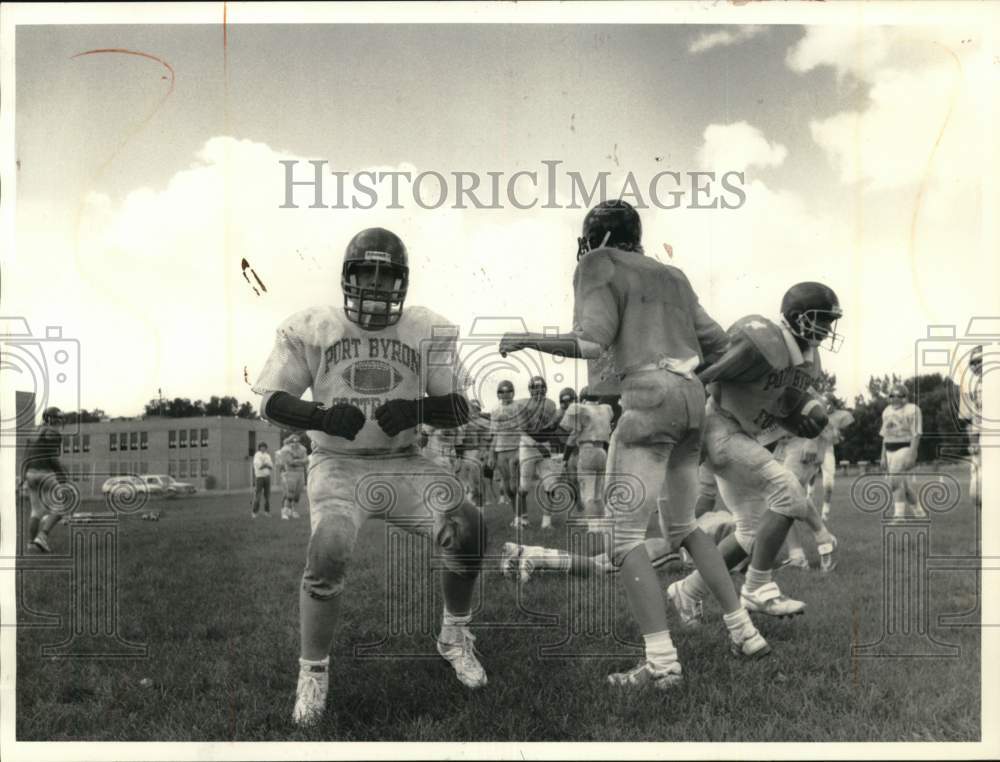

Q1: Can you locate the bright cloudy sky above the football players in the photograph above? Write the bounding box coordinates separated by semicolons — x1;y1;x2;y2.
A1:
2;7;998;415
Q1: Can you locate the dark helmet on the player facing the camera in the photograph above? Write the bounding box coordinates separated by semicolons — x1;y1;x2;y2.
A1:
340;228;410;330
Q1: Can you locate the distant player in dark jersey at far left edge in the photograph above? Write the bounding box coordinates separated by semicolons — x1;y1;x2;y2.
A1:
21;407;69;553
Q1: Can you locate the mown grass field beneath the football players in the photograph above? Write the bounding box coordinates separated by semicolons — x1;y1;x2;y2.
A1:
17;464;980;741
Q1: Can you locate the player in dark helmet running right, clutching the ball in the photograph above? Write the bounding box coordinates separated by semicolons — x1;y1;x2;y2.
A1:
667;282;843;624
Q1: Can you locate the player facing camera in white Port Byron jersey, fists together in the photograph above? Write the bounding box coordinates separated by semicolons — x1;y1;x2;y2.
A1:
254;228;486;726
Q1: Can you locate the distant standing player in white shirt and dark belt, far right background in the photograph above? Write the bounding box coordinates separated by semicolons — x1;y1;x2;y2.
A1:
879;384;927;519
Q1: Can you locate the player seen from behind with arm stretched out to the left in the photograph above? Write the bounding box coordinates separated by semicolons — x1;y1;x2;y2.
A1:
500;200;770;689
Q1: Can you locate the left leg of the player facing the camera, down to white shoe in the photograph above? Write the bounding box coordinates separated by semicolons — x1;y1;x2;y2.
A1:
292;452;367;726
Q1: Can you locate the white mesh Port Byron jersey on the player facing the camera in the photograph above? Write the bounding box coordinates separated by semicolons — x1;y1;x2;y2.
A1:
253;306;469;455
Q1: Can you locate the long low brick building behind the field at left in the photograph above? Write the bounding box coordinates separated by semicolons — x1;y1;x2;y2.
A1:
54;417;281;495
